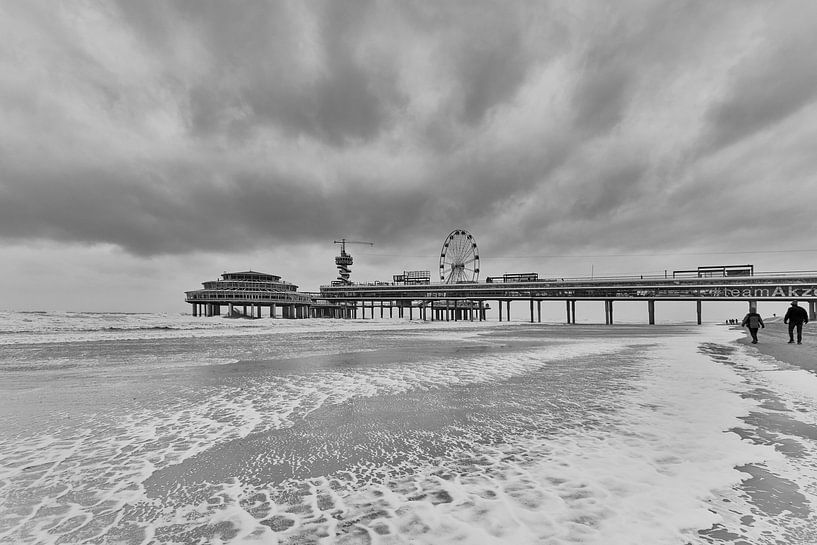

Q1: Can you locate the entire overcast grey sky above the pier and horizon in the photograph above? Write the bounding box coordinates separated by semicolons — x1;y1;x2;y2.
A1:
0;0;817;311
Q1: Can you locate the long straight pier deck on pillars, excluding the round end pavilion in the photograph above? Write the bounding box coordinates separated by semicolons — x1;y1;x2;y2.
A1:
320;268;817;324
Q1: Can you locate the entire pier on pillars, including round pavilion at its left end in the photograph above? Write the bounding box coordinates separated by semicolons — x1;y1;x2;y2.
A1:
185;266;817;325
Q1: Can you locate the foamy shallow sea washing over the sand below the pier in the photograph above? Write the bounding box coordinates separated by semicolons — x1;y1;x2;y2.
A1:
0;312;817;545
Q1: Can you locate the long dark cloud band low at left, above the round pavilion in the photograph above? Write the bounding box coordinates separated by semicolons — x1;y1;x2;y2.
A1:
0;154;440;255
